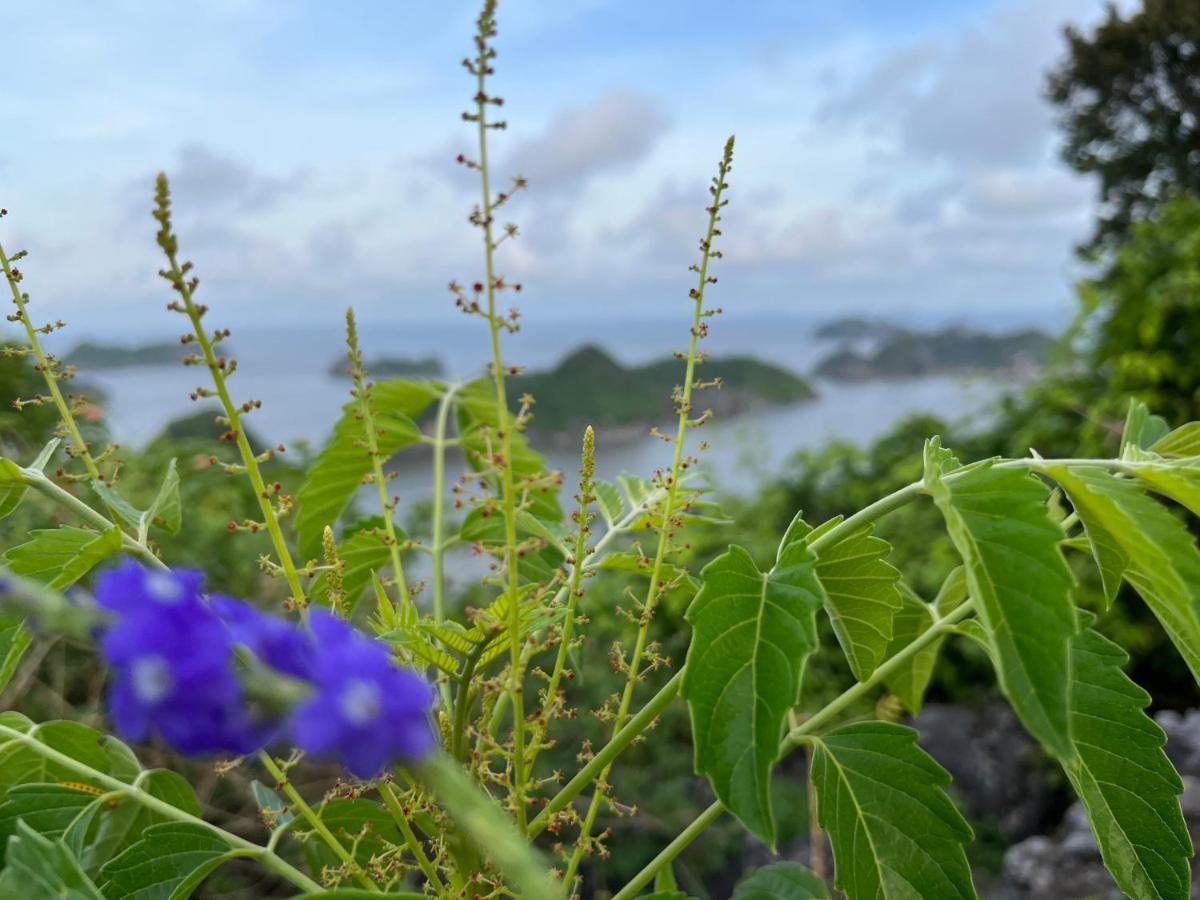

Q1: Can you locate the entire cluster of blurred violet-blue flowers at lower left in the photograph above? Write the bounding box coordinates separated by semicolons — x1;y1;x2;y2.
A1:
96;562;434;778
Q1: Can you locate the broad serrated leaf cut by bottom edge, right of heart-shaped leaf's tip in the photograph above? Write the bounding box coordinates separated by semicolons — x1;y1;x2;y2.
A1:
810;722;976;900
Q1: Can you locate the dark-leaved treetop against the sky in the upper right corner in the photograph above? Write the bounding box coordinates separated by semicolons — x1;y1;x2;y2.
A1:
1048;0;1200;251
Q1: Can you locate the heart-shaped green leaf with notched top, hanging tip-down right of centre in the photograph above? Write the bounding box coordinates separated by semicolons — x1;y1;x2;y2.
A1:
682;541;824;846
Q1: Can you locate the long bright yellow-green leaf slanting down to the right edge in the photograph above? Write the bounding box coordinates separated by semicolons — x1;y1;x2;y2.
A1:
1046;466;1200;680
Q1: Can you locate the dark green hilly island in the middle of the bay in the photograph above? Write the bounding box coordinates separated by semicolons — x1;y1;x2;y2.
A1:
512;346;816;437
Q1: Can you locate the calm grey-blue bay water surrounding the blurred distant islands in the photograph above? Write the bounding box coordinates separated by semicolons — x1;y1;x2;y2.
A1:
77;318;1014;500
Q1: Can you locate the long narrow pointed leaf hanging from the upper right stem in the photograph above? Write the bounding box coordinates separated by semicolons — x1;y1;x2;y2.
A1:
926;451;1078;756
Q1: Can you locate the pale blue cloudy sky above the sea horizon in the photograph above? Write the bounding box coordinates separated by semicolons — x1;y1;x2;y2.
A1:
0;0;1123;334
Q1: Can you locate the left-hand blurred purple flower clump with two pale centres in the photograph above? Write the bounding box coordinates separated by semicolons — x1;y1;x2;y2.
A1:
96;562;269;755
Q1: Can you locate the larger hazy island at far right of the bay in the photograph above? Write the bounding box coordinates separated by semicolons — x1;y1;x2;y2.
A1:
814;325;1055;382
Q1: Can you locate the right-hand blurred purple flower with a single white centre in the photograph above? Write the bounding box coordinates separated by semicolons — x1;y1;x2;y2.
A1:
290;610;436;778
